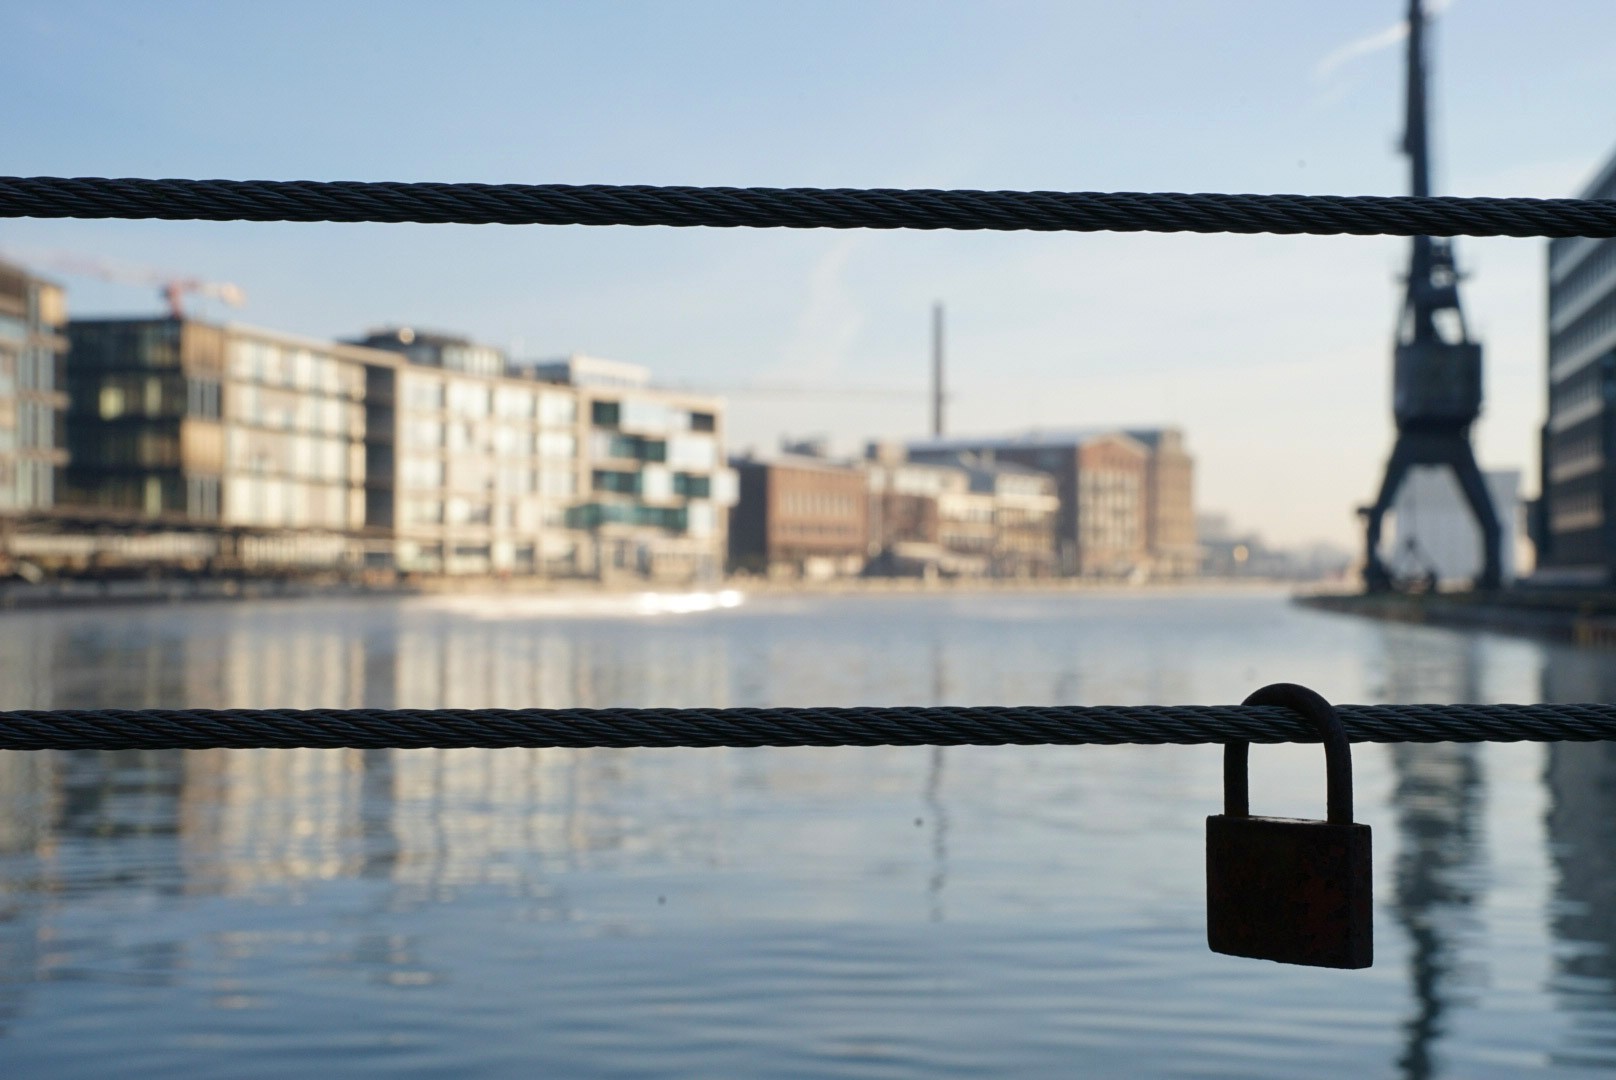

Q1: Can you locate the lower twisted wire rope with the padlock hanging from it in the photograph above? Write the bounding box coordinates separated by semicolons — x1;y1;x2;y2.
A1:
0;705;1616;750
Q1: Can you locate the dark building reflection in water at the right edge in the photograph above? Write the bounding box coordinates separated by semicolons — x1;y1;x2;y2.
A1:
1542;647;1616;1069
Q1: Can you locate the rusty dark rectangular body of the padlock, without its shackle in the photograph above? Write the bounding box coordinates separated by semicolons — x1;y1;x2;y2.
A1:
1207;813;1375;967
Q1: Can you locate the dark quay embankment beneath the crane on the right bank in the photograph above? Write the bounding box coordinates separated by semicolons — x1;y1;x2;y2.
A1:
1296;589;1616;648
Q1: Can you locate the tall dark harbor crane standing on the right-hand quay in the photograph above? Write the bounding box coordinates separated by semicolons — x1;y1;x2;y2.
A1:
1359;0;1501;592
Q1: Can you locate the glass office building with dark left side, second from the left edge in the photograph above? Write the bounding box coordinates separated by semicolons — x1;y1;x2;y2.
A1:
66;319;377;564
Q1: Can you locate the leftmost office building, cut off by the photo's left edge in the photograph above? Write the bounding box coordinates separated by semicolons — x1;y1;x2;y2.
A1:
0;264;68;513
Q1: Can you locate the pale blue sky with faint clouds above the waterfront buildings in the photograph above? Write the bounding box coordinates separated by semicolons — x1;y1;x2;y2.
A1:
0;0;1616;543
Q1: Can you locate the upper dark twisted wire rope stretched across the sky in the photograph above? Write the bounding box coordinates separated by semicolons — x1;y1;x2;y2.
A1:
9;176;1616;238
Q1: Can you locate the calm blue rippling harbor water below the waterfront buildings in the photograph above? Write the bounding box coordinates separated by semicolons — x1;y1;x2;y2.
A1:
0;590;1616;1080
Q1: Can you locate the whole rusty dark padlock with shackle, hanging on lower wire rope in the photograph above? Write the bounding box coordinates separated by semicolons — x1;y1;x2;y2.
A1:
1207;682;1375;968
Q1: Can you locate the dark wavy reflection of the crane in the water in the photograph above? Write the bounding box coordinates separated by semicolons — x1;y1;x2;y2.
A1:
1383;627;1487;1080
